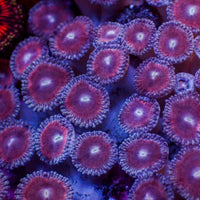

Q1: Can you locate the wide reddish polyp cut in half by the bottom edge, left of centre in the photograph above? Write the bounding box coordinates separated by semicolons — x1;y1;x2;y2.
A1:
15;171;74;200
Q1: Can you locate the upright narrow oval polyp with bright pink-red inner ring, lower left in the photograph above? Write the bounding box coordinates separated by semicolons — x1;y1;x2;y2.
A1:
35;115;75;165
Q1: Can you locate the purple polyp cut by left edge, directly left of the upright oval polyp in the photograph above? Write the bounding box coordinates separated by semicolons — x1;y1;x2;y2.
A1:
0;120;34;169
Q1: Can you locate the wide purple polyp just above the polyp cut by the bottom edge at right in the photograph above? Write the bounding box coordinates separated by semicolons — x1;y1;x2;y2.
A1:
119;133;169;178
